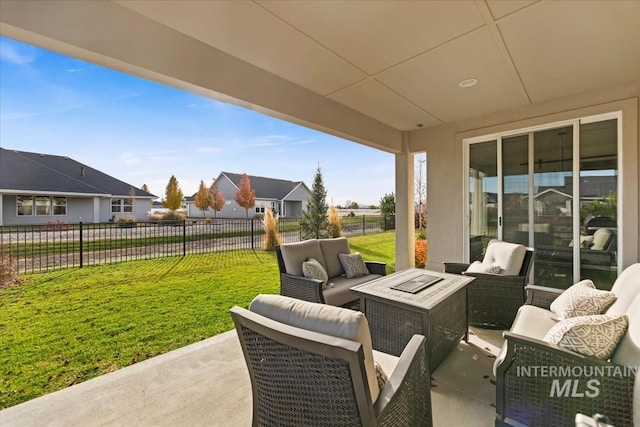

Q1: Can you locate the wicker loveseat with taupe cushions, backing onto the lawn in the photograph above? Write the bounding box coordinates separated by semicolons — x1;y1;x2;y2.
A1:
276;237;387;306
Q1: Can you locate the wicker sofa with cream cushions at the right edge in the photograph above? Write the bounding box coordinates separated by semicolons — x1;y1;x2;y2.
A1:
494;263;640;427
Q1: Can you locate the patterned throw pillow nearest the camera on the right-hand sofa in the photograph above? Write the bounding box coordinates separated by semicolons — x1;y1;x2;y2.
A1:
543;314;629;360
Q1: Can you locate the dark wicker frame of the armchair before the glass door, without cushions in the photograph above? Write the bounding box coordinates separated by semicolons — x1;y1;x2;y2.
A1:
444;243;534;329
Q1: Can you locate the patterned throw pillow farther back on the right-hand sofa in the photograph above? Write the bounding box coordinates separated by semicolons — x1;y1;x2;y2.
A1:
550;279;616;320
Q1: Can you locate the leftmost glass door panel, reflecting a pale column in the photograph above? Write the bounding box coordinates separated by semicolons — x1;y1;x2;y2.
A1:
469;141;498;262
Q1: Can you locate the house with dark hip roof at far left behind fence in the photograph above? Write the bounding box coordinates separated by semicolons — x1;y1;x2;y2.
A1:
0;148;156;225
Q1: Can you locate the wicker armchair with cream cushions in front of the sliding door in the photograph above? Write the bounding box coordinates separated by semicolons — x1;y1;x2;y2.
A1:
444;239;534;329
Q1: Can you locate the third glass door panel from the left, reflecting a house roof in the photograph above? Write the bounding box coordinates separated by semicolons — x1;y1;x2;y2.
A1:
533;126;574;289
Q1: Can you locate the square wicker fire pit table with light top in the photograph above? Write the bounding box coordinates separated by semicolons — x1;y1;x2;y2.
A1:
352;268;474;372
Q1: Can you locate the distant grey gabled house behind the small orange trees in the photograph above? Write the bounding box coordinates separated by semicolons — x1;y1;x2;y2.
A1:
186;172;311;218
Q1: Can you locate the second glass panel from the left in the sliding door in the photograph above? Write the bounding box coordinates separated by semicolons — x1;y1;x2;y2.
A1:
502;135;530;246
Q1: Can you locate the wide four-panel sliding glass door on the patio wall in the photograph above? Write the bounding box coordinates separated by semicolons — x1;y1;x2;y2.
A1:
467;119;618;289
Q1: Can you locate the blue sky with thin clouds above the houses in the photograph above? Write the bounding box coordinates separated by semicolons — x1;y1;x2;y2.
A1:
0;37;394;205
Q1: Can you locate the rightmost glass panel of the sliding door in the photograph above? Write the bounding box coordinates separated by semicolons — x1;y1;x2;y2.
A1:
580;119;618;289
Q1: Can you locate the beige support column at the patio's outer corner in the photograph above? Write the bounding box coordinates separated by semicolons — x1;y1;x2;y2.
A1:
396;132;415;271
